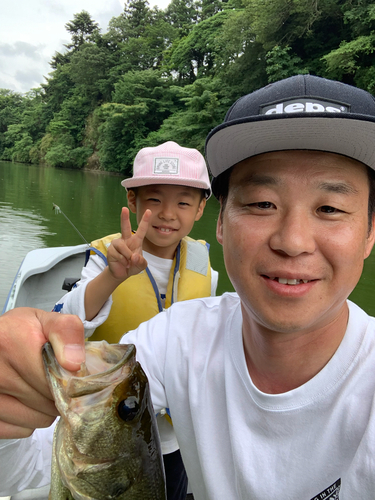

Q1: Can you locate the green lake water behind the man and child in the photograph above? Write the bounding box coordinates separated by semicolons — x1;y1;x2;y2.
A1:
0;162;375;315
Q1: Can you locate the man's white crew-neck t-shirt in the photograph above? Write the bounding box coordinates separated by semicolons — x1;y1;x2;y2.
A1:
0;294;375;500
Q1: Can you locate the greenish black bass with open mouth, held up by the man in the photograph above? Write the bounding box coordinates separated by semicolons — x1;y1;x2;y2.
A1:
43;341;166;500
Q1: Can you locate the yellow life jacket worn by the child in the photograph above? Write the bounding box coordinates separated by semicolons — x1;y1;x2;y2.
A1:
87;233;211;343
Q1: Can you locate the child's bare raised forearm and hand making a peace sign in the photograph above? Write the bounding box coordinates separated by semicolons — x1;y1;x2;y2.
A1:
85;208;151;321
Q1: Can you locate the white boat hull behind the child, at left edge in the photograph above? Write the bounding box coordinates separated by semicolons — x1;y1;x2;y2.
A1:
3;244;89;313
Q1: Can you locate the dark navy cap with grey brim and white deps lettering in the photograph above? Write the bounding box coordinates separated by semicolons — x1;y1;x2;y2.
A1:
206;75;375;194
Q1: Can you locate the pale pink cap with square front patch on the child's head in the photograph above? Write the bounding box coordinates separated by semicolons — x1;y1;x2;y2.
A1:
121;141;211;198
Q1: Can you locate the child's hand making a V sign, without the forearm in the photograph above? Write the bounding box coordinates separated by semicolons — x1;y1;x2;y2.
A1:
107;207;152;282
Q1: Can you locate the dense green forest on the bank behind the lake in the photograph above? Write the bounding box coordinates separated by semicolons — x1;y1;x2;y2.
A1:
0;0;375;176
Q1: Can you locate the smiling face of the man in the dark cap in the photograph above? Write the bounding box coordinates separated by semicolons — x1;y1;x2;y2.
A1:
217;151;374;332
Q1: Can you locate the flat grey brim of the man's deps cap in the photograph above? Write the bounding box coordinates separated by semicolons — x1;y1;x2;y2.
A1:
206;113;375;177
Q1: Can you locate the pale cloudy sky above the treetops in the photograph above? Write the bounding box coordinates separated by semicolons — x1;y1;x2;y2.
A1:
0;0;170;93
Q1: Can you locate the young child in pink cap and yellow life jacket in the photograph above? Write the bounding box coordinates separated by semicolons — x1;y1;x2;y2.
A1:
55;142;218;500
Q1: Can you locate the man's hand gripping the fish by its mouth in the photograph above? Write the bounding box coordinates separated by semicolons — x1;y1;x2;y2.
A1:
0;308;85;439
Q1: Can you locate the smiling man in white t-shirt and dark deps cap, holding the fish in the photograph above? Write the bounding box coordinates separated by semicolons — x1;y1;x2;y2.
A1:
0;75;375;500
